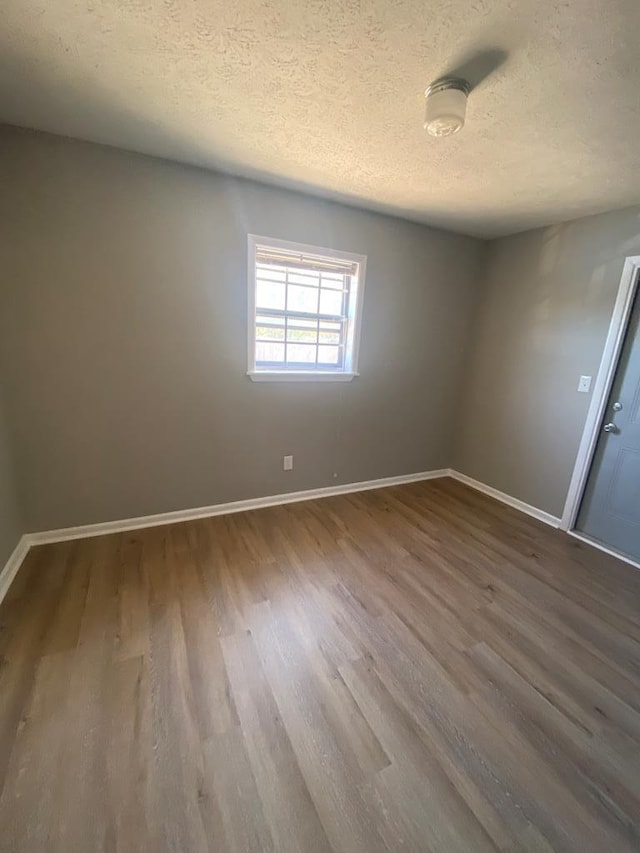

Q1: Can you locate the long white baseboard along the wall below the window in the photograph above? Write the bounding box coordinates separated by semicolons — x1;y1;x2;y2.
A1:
27;468;449;545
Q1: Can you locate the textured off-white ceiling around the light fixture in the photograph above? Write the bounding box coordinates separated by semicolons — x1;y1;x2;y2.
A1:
0;0;640;237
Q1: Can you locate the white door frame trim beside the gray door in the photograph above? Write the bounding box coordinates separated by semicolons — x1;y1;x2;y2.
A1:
560;255;640;532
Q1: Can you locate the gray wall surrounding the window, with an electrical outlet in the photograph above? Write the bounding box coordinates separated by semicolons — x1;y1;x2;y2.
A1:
0;129;485;530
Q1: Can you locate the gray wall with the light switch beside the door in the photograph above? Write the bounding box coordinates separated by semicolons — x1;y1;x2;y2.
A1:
454;208;640;516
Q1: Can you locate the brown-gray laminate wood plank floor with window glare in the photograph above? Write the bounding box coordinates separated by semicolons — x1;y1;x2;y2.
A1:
0;479;640;853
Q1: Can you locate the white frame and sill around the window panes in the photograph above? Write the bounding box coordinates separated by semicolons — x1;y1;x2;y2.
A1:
247;234;367;382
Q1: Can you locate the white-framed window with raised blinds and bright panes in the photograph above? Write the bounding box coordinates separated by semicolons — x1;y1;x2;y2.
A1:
249;235;366;381
